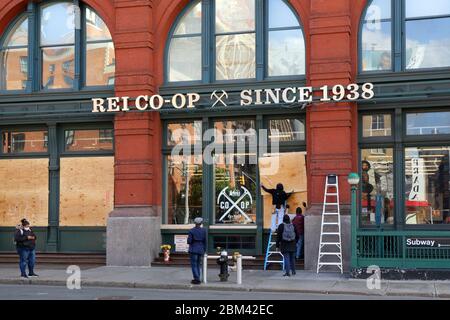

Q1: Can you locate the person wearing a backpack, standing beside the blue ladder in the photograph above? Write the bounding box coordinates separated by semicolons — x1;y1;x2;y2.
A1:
276;215;299;277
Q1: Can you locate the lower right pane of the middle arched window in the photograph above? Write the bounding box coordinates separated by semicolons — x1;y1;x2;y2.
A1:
269;29;305;76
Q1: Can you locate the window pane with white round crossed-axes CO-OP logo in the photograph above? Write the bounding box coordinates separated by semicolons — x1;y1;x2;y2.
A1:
214;154;257;224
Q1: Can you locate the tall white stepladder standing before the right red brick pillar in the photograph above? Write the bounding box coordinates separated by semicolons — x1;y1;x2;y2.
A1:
317;174;343;273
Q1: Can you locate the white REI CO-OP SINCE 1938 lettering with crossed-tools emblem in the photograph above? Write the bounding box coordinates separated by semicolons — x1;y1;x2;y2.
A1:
92;83;374;112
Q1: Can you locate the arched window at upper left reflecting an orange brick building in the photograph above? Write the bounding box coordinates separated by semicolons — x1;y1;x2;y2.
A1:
0;1;115;92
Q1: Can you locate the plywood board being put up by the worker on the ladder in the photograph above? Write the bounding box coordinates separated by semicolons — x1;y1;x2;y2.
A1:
258;152;307;195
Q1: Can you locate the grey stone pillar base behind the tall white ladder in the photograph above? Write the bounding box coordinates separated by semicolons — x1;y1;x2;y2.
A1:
304;205;351;272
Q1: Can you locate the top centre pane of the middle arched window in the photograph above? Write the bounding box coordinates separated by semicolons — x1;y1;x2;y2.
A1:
216;0;255;33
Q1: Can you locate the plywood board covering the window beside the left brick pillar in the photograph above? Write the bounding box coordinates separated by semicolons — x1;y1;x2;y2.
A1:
59;157;114;226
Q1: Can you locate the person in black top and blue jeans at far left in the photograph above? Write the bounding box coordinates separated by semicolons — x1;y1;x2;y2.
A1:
14;219;37;279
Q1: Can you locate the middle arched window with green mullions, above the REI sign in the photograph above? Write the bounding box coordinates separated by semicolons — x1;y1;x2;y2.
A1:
166;0;305;83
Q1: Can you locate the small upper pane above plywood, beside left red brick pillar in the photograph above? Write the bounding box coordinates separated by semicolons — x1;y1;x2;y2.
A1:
64;129;114;152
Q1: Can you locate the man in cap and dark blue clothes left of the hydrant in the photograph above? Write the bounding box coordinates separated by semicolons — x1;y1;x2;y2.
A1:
188;217;206;284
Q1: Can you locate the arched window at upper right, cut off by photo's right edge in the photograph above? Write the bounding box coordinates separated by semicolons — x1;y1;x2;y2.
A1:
360;0;450;72
